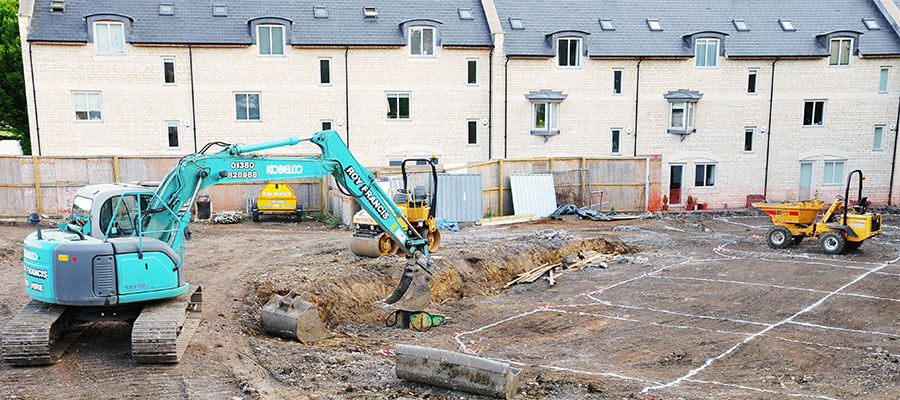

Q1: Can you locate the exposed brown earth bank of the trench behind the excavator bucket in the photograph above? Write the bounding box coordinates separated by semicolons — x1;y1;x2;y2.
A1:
242;237;639;333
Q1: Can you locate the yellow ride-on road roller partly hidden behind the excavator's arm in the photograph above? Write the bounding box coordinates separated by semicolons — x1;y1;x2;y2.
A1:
350;158;441;257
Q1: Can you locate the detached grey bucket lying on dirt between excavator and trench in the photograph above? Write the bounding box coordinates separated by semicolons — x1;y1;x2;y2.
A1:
260;290;328;343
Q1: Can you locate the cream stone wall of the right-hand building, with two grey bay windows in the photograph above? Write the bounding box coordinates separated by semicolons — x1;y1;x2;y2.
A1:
495;52;900;208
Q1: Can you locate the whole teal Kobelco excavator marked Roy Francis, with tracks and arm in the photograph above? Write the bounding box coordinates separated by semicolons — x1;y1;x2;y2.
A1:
2;130;434;365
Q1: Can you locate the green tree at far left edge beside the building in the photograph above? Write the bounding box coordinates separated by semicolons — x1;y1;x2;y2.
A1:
0;0;31;154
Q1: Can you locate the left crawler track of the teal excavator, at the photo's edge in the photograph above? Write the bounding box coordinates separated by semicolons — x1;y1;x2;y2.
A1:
2;300;89;365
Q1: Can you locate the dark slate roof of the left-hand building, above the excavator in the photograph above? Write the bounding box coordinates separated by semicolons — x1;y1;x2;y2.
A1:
28;0;493;46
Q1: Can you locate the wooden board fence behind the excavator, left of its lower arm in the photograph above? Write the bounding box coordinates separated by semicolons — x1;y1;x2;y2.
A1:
0;156;325;217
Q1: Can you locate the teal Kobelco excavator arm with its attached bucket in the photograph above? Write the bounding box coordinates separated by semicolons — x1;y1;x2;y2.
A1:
142;131;433;311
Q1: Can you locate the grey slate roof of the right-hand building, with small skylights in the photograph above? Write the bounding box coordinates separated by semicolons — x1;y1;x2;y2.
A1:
494;0;900;57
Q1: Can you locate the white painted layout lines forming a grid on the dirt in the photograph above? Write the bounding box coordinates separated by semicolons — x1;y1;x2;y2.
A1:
453;223;900;399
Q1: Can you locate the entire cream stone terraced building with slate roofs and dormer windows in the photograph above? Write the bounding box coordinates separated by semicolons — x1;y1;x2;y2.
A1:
20;0;900;207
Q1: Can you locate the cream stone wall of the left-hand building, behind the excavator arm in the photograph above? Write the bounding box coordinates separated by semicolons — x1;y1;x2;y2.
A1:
26;38;489;166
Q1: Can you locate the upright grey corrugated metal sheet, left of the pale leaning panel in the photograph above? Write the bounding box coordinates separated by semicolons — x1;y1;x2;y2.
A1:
435;174;484;222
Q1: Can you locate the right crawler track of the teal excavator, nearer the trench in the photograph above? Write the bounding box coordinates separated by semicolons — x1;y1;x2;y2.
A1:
131;287;203;363
